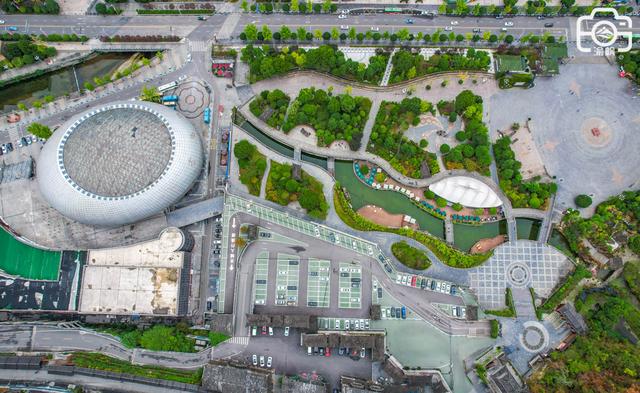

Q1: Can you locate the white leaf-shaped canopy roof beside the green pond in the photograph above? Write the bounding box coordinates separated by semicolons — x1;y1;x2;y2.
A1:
429;176;502;208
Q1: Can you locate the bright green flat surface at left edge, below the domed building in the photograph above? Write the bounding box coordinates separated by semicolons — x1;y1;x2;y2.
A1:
0;225;61;281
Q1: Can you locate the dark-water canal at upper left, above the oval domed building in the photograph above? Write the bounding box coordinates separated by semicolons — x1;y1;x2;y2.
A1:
0;52;153;112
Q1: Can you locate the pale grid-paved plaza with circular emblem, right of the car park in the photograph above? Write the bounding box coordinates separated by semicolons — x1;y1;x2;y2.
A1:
469;240;573;309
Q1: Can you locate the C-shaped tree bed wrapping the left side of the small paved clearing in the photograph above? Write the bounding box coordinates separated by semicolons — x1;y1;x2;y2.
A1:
367;97;440;179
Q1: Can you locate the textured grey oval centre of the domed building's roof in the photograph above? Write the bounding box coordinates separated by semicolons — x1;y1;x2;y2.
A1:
61;108;172;197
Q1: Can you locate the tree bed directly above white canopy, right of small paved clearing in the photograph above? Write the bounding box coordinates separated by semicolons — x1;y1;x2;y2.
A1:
437;90;491;176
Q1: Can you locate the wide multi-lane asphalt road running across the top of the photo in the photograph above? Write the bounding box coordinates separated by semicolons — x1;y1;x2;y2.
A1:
4;14;640;41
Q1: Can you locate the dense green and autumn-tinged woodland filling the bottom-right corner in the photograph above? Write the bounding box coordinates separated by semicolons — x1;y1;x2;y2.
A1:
528;261;640;393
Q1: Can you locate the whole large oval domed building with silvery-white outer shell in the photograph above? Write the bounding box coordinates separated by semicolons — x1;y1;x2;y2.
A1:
37;101;204;227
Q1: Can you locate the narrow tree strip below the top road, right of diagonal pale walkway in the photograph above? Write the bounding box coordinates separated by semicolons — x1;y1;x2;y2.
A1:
389;48;491;83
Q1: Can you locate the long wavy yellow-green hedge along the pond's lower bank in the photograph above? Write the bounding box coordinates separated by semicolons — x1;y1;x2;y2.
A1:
333;182;493;269
